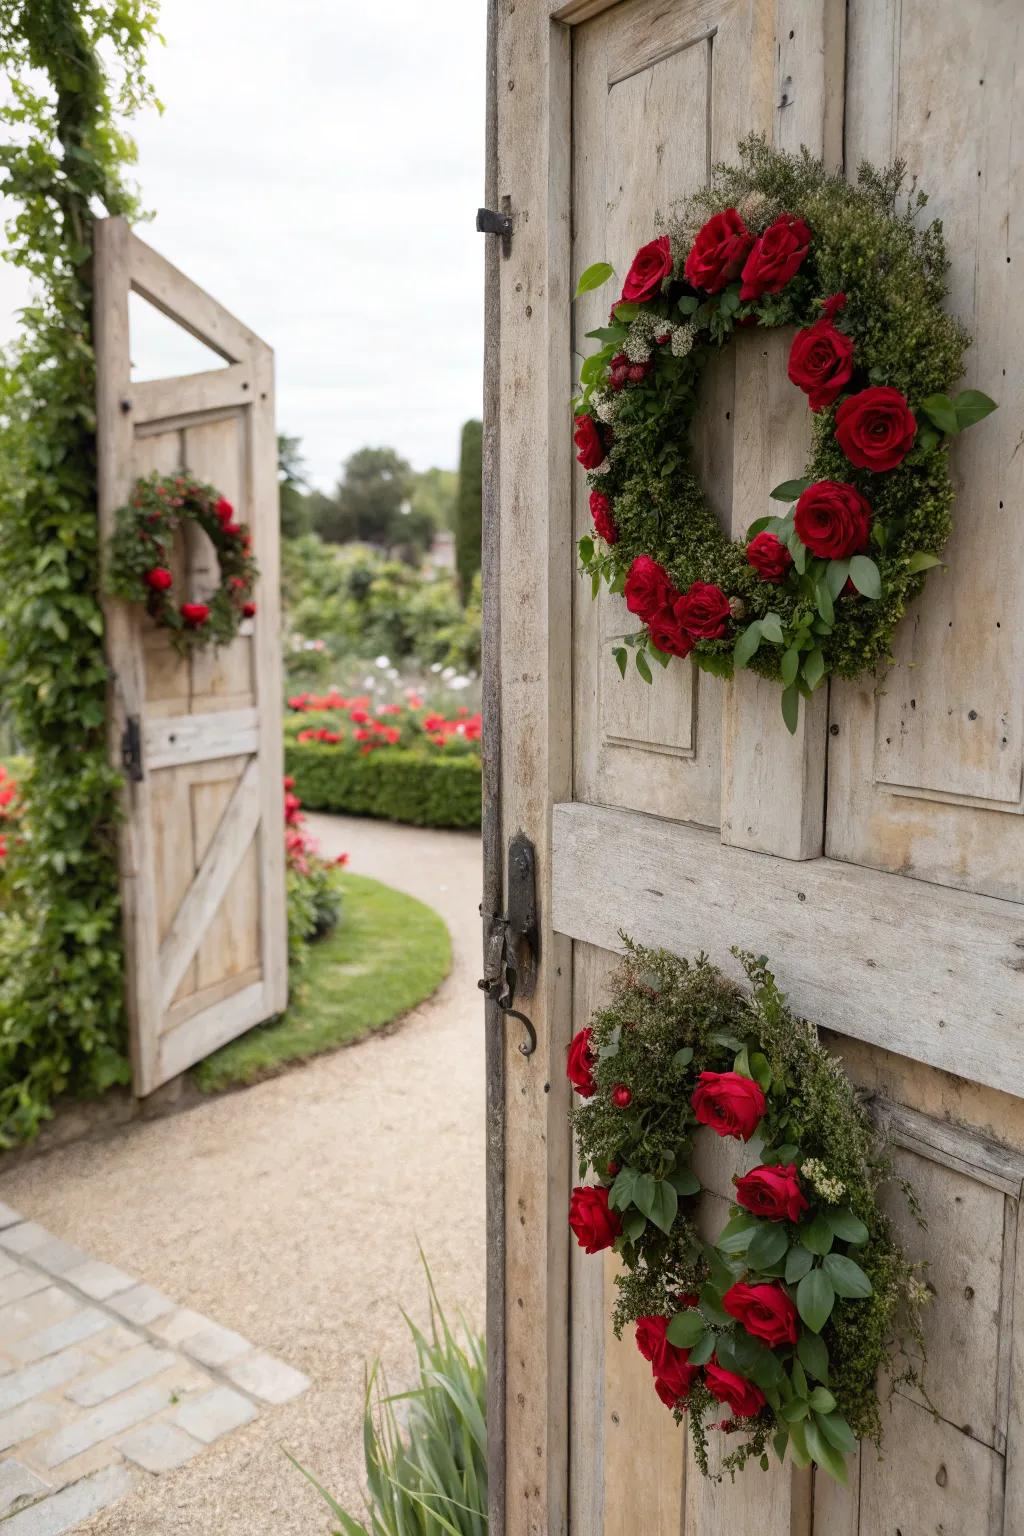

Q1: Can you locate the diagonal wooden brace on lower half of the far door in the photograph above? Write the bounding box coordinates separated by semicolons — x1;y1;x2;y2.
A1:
160;757;259;1009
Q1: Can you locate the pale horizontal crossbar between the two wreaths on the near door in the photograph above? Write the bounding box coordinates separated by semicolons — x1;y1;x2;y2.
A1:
551;803;1024;1097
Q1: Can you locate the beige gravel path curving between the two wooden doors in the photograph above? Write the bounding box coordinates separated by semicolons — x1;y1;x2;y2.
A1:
0;816;484;1536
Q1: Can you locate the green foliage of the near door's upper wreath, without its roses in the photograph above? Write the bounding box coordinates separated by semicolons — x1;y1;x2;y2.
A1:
574;135;993;728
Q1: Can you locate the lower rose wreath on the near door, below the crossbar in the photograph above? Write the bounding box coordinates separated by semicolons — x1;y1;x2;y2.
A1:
568;935;929;1482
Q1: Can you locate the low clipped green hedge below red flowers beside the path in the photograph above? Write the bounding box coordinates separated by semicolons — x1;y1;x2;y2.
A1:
284;737;481;826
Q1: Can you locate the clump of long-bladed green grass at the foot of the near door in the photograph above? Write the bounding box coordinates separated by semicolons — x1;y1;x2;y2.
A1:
290;1272;487;1536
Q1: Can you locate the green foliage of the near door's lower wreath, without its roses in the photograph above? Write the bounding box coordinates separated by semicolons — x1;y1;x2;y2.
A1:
573;940;929;1481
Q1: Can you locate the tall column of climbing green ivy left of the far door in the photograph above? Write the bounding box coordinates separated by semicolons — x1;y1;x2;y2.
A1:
0;0;157;1146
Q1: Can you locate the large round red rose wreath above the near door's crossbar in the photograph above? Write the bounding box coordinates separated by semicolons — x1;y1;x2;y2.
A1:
573;135;995;731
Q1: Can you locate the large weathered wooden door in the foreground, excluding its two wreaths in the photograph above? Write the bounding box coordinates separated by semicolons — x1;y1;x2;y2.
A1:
485;0;1024;1536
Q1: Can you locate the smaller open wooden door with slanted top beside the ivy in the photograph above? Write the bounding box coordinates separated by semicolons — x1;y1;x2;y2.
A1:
95;218;287;1094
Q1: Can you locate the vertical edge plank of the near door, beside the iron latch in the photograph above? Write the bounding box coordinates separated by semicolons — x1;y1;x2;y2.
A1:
497;5;573;1536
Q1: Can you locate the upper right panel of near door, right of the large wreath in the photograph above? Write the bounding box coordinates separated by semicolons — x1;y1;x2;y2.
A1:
827;0;1024;900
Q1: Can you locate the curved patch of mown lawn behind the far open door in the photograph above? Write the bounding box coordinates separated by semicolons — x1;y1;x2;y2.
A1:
192;874;451;1094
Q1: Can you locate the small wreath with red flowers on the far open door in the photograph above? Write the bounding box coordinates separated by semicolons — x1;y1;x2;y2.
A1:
107;473;259;653
